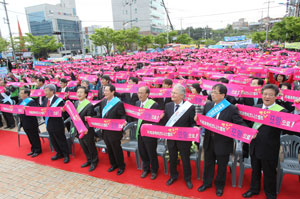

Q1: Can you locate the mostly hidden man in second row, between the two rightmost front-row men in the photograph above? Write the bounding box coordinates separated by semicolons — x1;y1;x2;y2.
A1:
238;78;264;158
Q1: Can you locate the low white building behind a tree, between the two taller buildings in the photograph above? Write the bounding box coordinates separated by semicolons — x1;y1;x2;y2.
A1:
83;25;106;55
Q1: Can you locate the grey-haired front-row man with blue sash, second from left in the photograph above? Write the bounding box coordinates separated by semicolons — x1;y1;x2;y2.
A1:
42;84;70;163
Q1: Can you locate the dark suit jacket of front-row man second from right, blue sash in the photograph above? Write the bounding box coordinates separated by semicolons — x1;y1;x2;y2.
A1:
203;102;247;155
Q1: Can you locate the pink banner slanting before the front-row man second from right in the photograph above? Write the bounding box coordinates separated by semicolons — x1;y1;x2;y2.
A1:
197;114;257;144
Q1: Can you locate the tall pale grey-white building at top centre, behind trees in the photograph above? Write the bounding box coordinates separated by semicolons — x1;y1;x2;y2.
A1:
111;0;166;34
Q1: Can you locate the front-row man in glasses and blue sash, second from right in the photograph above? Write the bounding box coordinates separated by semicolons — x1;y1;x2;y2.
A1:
198;84;247;196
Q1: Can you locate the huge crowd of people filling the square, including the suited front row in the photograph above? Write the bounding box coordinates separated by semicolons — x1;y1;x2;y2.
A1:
0;49;300;198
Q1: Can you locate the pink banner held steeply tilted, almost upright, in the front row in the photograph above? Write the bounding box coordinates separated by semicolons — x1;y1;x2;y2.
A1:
64;101;88;139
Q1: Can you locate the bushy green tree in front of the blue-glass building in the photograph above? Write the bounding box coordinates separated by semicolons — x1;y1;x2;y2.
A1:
25;33;63;58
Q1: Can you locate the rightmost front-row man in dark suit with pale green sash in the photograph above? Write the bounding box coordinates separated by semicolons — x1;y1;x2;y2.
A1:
242;84;287;199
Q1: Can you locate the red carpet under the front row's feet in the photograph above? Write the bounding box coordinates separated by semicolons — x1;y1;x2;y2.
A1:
0;130;300;199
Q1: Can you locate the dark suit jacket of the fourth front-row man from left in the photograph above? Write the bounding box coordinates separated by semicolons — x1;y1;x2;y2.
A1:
100;99;126;134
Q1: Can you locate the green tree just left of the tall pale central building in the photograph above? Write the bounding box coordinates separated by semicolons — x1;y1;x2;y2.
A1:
90;27;114;55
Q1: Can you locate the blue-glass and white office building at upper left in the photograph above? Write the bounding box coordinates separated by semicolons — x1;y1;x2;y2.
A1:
25;0;82;54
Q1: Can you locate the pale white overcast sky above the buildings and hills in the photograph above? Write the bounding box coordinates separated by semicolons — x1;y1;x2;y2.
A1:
0;0;287;38
